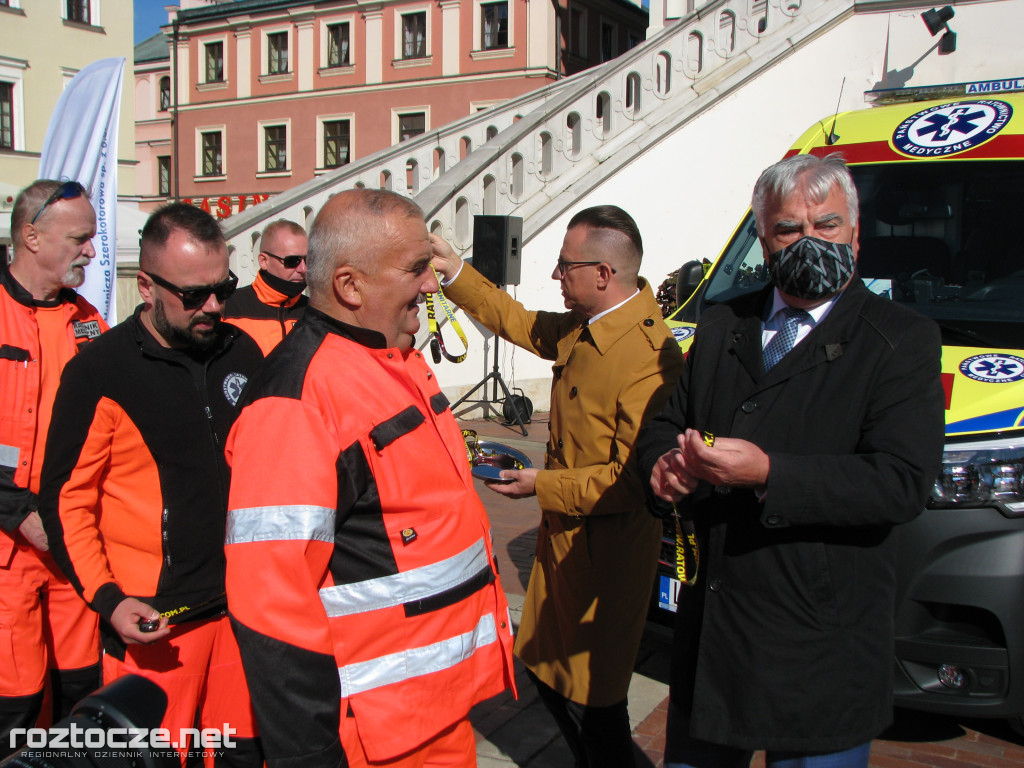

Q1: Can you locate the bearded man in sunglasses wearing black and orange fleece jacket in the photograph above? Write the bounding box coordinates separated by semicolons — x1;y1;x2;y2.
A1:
41;204;262;766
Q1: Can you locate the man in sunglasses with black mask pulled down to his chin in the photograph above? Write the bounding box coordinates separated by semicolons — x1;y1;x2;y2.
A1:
224;219;309;354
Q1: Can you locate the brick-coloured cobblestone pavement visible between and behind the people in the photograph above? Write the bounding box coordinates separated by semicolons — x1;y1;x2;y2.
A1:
457;412;1024;768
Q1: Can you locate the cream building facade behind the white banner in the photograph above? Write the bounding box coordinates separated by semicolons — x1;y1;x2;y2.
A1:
0;0;135;253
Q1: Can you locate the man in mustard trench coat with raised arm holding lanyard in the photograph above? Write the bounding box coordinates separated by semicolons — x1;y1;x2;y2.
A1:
431;206;683;768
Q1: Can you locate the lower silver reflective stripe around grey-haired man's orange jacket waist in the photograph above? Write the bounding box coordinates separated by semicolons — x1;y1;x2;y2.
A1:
338;613;498;698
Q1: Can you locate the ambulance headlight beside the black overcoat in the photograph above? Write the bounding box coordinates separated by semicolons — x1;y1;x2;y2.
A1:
928;437;1024;517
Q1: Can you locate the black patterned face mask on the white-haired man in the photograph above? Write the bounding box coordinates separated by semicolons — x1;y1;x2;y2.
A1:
768;237;856;299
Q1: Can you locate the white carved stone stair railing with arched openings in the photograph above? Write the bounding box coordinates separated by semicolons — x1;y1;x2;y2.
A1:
224;0;855;276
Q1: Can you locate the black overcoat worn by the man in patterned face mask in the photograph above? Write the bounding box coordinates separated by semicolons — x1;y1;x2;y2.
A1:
637;278;944;752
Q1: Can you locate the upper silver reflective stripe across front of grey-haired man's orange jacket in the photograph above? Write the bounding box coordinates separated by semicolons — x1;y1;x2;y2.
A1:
321;539;490;616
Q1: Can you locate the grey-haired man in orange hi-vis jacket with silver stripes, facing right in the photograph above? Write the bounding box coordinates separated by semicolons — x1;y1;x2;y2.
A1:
225;189;513;768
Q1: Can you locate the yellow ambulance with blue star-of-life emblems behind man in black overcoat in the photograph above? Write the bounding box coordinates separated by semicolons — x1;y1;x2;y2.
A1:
656;79;1024;732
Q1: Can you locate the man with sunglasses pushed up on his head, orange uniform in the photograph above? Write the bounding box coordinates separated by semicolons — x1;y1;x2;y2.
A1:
0;179;106;758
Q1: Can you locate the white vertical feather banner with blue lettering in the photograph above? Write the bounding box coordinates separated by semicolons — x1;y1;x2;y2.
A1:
39;56;125;326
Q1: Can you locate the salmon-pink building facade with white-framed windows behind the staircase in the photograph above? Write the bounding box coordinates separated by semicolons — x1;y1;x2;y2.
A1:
135;0;647;218
